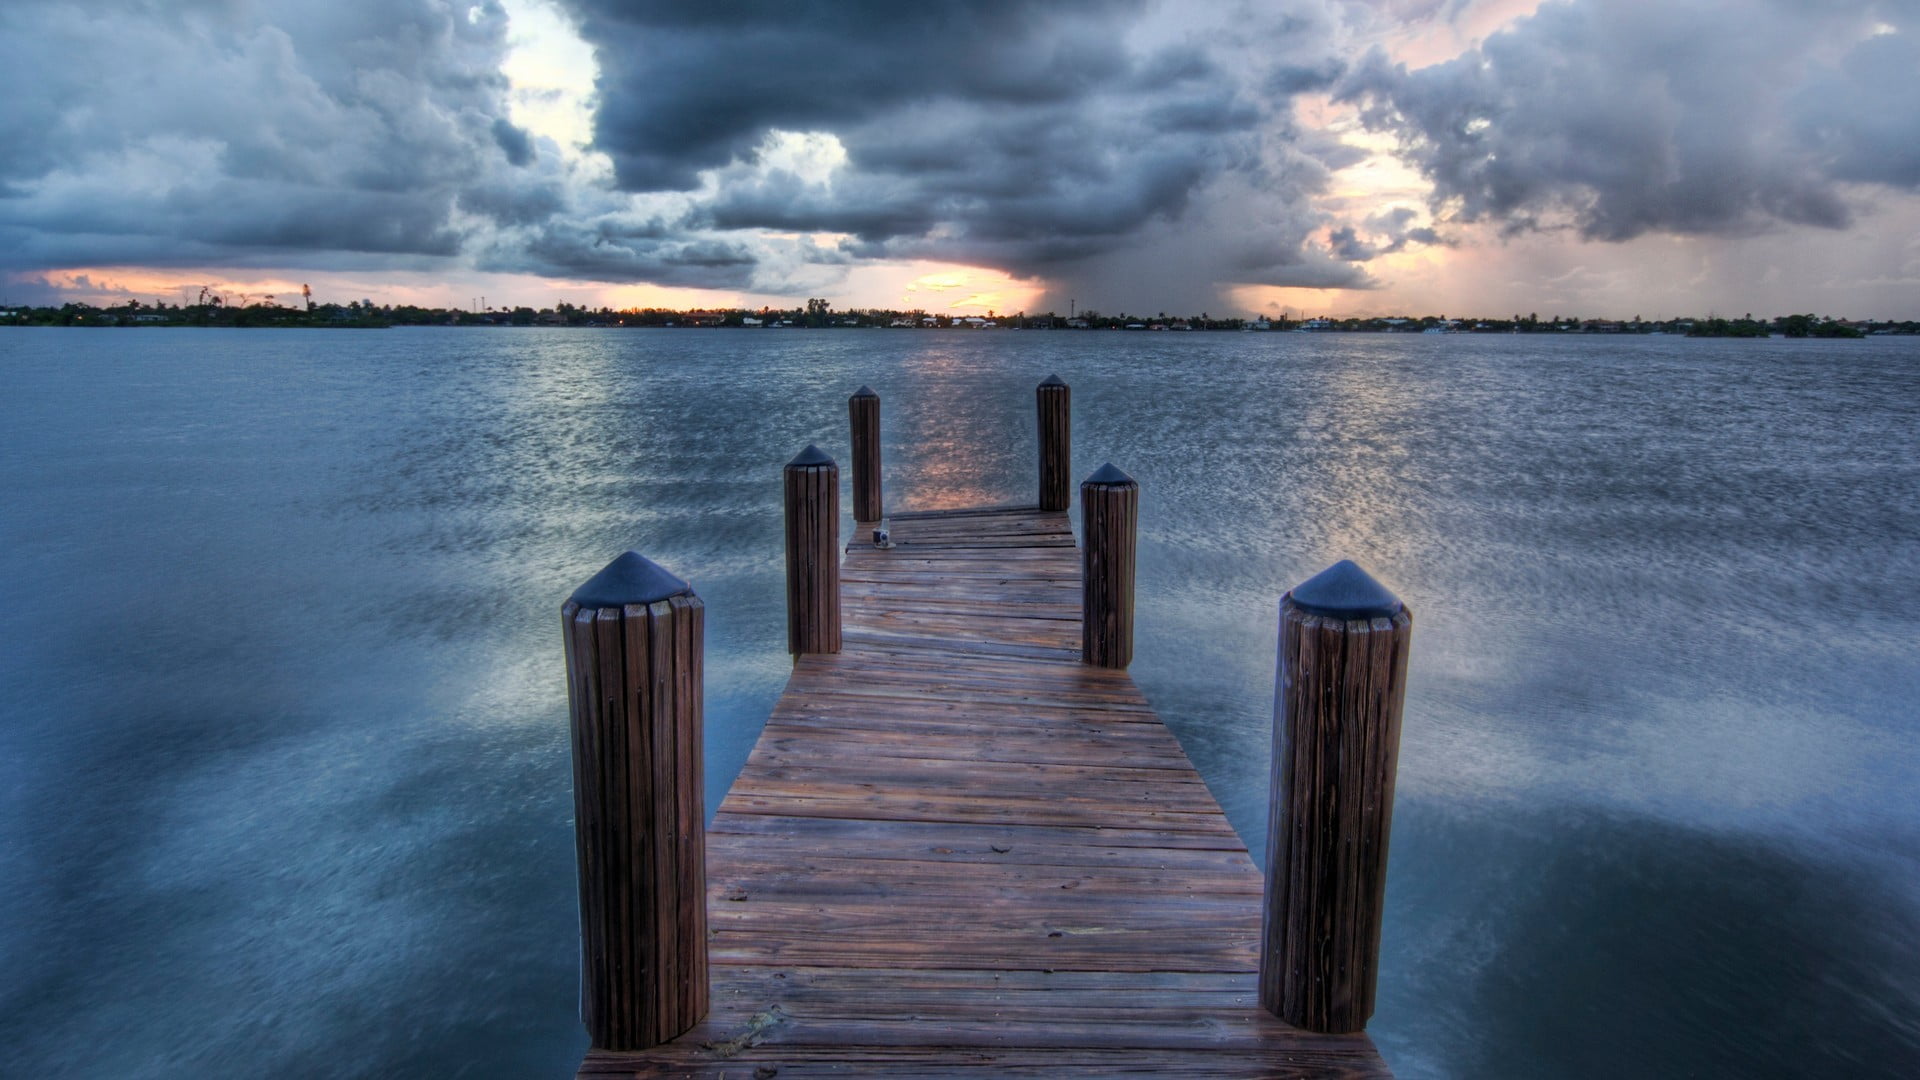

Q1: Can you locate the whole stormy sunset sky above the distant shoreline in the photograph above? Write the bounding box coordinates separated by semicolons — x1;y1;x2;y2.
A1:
0;0;1920;319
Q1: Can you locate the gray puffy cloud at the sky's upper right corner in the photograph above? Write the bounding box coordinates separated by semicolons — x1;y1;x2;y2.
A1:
1338;0;1920;240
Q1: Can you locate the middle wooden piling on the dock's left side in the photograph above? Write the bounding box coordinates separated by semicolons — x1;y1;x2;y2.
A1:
785;444;841;655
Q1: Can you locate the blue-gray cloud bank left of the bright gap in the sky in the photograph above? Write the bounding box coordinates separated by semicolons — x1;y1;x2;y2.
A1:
0;0;561;265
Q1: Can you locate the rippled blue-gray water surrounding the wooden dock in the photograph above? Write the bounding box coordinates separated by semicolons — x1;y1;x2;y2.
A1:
0;329;1920;1078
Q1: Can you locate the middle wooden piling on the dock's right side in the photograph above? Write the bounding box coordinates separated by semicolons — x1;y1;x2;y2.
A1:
1062;461;1140;667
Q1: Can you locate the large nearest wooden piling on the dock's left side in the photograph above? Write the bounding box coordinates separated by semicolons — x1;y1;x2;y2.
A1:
561;552;708;1049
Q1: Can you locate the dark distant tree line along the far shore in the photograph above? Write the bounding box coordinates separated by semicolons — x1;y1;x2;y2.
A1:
0;298;1920;338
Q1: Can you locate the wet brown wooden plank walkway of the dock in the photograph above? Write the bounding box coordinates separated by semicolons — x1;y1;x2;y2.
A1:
580;507;1390;1078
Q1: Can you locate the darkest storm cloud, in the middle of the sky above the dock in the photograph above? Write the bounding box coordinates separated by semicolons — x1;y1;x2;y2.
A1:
566;0;1363;298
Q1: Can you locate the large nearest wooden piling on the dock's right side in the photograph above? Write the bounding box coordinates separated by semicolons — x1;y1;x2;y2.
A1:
1260;561;1413;1032
